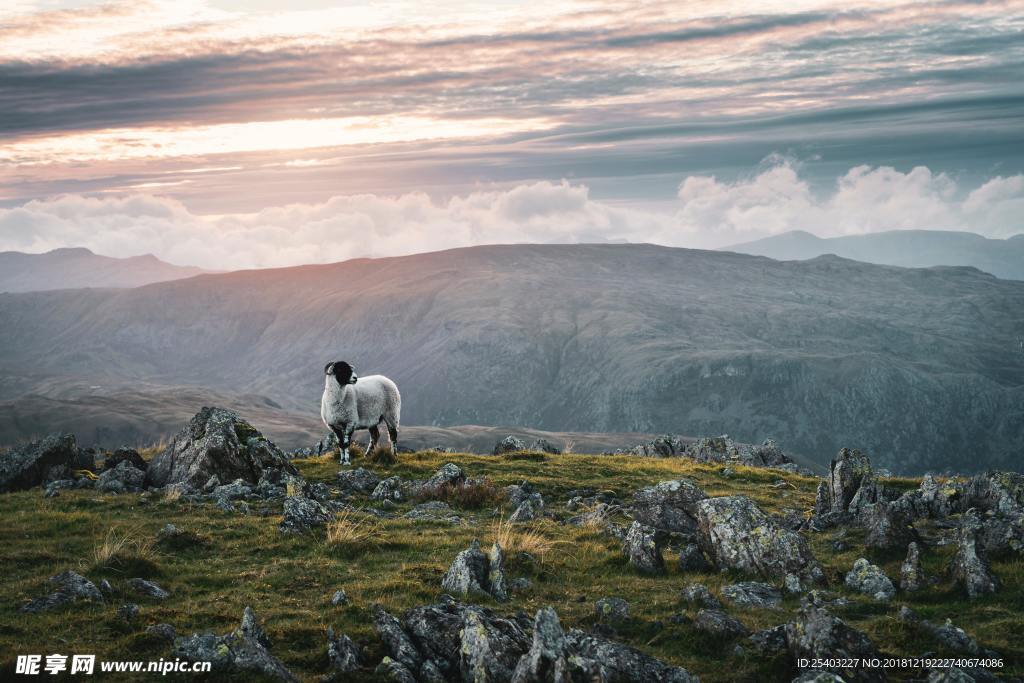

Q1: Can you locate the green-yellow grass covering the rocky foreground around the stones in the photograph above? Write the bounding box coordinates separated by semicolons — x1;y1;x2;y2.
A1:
0;453;1024;681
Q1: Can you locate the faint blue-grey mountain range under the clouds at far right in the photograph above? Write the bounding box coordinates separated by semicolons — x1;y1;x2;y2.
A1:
721;230;1024;280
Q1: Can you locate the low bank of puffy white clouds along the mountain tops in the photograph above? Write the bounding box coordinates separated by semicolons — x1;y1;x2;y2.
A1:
0;161;1024;269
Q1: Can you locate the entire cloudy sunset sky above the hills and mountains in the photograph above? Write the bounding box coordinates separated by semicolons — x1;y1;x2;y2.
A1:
0;0;1024;269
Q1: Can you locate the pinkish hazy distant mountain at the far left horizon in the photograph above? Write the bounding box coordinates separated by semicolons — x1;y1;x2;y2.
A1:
0;248;207;292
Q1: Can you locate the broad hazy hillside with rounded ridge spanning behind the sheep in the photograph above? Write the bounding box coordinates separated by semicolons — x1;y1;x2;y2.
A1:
0;245;1024;471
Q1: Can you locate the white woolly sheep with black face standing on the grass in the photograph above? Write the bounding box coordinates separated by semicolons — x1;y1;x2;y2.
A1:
321;360;401;465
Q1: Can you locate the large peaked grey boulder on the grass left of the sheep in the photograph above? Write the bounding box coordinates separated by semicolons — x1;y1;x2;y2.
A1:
146;408;296;488
